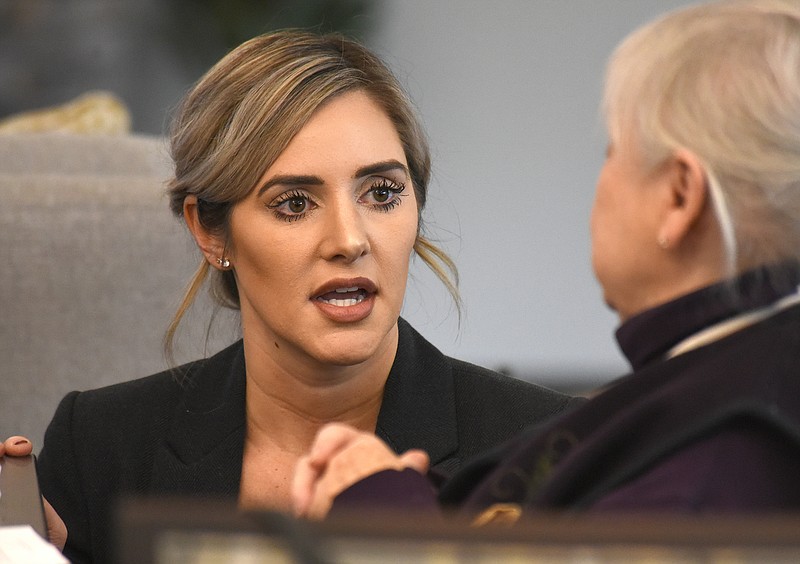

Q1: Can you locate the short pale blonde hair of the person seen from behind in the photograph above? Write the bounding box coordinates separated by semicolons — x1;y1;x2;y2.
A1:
603;0;800;275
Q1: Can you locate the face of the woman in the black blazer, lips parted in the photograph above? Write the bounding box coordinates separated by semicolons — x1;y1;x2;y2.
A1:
223;91;417;366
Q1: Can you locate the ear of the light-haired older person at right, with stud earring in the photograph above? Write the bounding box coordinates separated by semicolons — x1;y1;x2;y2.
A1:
658;149;709;248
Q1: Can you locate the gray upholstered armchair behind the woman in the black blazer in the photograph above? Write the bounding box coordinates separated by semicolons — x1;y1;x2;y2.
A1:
0;133;238;451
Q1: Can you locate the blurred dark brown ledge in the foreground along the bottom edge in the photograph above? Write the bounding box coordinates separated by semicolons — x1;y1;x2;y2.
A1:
115;499;800;564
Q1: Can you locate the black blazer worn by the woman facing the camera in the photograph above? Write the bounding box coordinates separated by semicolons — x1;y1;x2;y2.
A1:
38;319;573;562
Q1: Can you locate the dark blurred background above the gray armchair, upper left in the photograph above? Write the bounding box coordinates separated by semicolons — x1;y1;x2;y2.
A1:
0;0;374;134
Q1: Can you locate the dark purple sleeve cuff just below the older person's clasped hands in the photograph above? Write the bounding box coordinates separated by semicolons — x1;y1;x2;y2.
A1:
329;468;439;517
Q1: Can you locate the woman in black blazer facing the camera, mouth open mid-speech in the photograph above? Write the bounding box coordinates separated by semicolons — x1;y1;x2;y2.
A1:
3;31;572;562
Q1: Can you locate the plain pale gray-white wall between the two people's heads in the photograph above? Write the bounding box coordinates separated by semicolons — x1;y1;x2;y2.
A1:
372;0;687;384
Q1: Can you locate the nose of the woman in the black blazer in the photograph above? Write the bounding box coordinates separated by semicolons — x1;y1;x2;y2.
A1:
321;198;370;263
